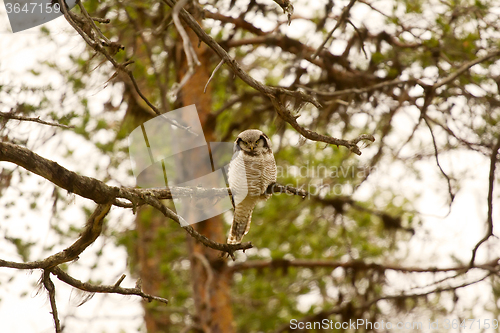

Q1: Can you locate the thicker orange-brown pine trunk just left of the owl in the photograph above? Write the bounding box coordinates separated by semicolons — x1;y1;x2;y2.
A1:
178;5;235;333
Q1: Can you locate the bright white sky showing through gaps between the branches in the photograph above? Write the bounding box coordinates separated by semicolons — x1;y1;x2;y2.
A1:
0;0;500;333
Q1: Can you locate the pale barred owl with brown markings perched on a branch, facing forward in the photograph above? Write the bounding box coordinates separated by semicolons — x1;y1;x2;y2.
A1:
227;129;276;244
